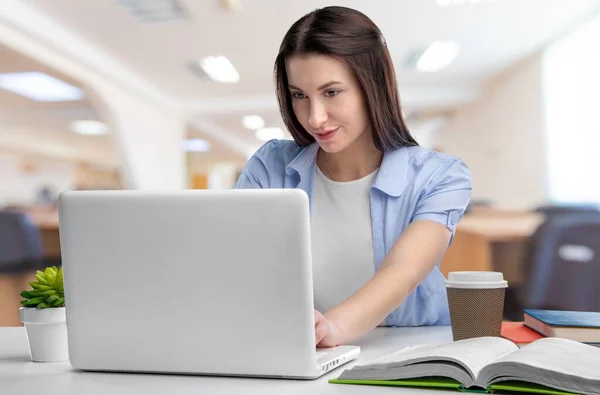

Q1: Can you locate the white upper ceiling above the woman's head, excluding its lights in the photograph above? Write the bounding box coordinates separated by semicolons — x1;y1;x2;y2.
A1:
0;0;600;157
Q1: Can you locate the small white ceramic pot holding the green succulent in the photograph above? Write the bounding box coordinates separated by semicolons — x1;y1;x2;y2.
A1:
20;307;69;362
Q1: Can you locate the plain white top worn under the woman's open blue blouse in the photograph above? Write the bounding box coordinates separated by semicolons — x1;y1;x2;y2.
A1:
311;166;377;312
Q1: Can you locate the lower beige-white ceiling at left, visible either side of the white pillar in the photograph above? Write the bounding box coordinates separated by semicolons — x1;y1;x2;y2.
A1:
0;45;243;167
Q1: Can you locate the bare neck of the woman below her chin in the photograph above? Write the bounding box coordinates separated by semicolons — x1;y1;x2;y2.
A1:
317;141;383;182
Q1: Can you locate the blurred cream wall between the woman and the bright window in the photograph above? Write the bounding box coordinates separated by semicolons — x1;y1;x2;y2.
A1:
435;54;547;212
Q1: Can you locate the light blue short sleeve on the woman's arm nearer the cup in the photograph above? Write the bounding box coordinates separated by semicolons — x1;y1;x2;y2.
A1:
411;159;472;235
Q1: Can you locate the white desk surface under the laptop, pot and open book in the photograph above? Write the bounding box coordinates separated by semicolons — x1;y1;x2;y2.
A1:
0;327;452;395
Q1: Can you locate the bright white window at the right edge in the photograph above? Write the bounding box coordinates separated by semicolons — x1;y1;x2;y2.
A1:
542;15;600;203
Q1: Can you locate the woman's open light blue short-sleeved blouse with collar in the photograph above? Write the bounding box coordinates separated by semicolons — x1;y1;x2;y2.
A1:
235;140;471;326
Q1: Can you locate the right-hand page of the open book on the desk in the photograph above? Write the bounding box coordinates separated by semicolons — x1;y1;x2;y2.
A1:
488;337;600;381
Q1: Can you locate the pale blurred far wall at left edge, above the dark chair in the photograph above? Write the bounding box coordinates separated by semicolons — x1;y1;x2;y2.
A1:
0;152;77;207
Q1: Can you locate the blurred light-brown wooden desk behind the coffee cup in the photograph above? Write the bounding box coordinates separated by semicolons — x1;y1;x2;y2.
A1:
440;211;544;286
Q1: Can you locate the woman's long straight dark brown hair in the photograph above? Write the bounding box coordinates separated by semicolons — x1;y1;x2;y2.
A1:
274;7;418;152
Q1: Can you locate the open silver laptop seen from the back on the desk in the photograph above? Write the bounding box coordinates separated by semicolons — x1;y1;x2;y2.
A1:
59;189;360;379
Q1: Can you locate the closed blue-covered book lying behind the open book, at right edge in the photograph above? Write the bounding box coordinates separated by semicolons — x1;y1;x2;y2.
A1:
523;309;600;343
